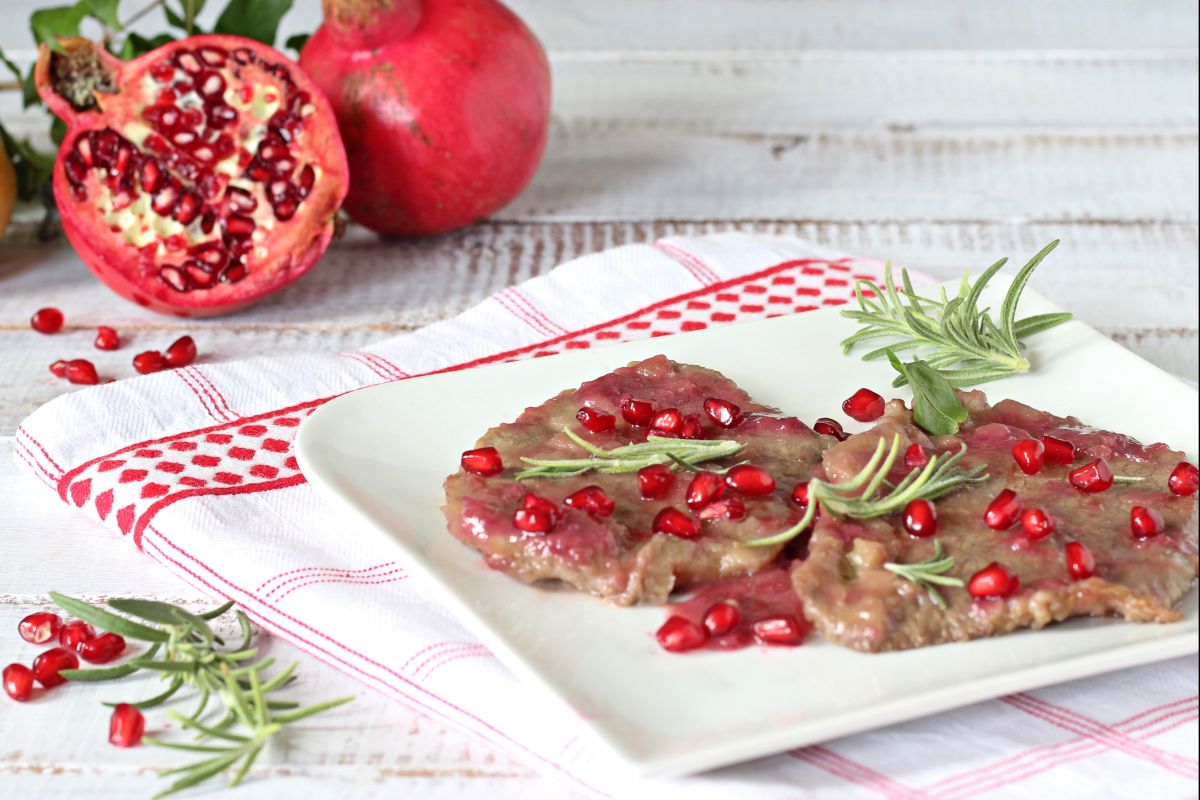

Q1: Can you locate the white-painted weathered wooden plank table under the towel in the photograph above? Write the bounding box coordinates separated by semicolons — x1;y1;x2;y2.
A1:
0;0;1198;800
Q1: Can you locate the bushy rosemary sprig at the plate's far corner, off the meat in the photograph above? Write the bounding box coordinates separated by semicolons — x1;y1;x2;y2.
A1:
841;240;1070;386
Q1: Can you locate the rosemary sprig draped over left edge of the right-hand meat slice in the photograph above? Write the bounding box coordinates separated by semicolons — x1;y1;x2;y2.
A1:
743;434;988;547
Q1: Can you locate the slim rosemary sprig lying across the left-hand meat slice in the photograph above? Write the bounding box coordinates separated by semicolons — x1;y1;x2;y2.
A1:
516;428;743;481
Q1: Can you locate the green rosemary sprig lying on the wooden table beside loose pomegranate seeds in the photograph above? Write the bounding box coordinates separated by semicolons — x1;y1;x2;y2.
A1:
50;591;353;798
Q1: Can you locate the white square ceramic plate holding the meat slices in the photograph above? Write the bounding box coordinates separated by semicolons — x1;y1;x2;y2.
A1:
298;275;1198;775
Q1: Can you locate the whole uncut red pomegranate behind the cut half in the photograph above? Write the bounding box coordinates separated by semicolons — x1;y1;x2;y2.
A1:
300;0;550;235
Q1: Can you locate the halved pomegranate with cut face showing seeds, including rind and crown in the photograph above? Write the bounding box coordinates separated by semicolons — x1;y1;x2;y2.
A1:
35;36;348;317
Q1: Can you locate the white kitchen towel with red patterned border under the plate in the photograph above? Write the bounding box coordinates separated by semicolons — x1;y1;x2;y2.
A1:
16;234;1200;800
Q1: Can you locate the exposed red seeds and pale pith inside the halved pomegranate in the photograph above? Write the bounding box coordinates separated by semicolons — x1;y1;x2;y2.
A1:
64;46;322;293
